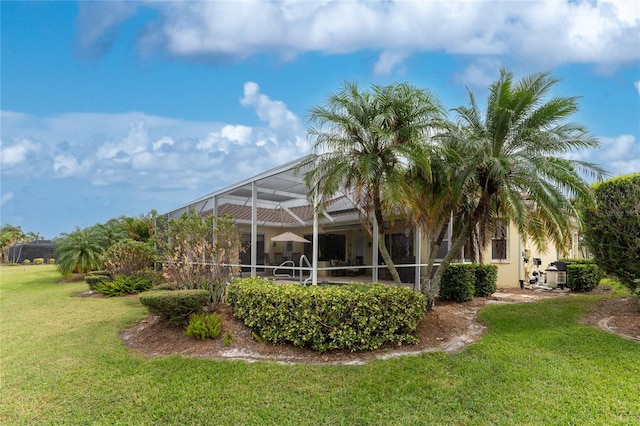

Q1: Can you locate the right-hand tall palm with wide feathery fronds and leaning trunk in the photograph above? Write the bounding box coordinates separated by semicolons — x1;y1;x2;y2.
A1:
429;69;606;305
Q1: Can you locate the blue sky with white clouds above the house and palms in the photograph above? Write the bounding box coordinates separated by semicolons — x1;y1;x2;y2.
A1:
0;0;640;238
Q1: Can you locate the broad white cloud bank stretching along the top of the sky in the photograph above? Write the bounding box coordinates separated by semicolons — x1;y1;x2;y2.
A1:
76;0;640;74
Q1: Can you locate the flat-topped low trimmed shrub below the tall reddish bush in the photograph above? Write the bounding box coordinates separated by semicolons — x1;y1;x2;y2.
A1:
140;290;210;324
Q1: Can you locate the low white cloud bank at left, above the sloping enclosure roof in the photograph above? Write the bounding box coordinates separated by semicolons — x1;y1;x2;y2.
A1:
0;82;309;191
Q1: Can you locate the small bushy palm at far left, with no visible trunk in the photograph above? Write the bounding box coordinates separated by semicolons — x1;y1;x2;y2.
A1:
56;228;105;277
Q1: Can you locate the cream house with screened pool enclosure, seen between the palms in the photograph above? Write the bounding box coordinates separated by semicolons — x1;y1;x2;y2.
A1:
166;161;578;290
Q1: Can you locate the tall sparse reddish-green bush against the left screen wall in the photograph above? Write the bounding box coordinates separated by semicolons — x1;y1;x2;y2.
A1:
156;211;241;303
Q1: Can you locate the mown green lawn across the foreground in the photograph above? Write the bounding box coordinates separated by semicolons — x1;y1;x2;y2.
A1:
0;265;640;425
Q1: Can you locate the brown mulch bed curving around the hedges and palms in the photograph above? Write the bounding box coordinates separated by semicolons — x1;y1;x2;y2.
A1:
116;287;640;364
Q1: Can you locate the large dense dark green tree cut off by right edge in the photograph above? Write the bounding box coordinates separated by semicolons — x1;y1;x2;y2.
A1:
582;173;640;290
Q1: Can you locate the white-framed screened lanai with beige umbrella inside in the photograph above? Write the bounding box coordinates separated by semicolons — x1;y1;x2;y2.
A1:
167;160;422;284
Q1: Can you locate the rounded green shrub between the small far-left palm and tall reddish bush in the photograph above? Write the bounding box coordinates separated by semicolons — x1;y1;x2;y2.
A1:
104;239;156;276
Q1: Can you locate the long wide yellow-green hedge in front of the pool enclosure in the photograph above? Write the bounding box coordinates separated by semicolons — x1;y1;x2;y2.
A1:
227;278;427;353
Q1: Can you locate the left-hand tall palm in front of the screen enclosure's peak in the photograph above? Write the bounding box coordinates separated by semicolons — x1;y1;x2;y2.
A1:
298;82;444;284
